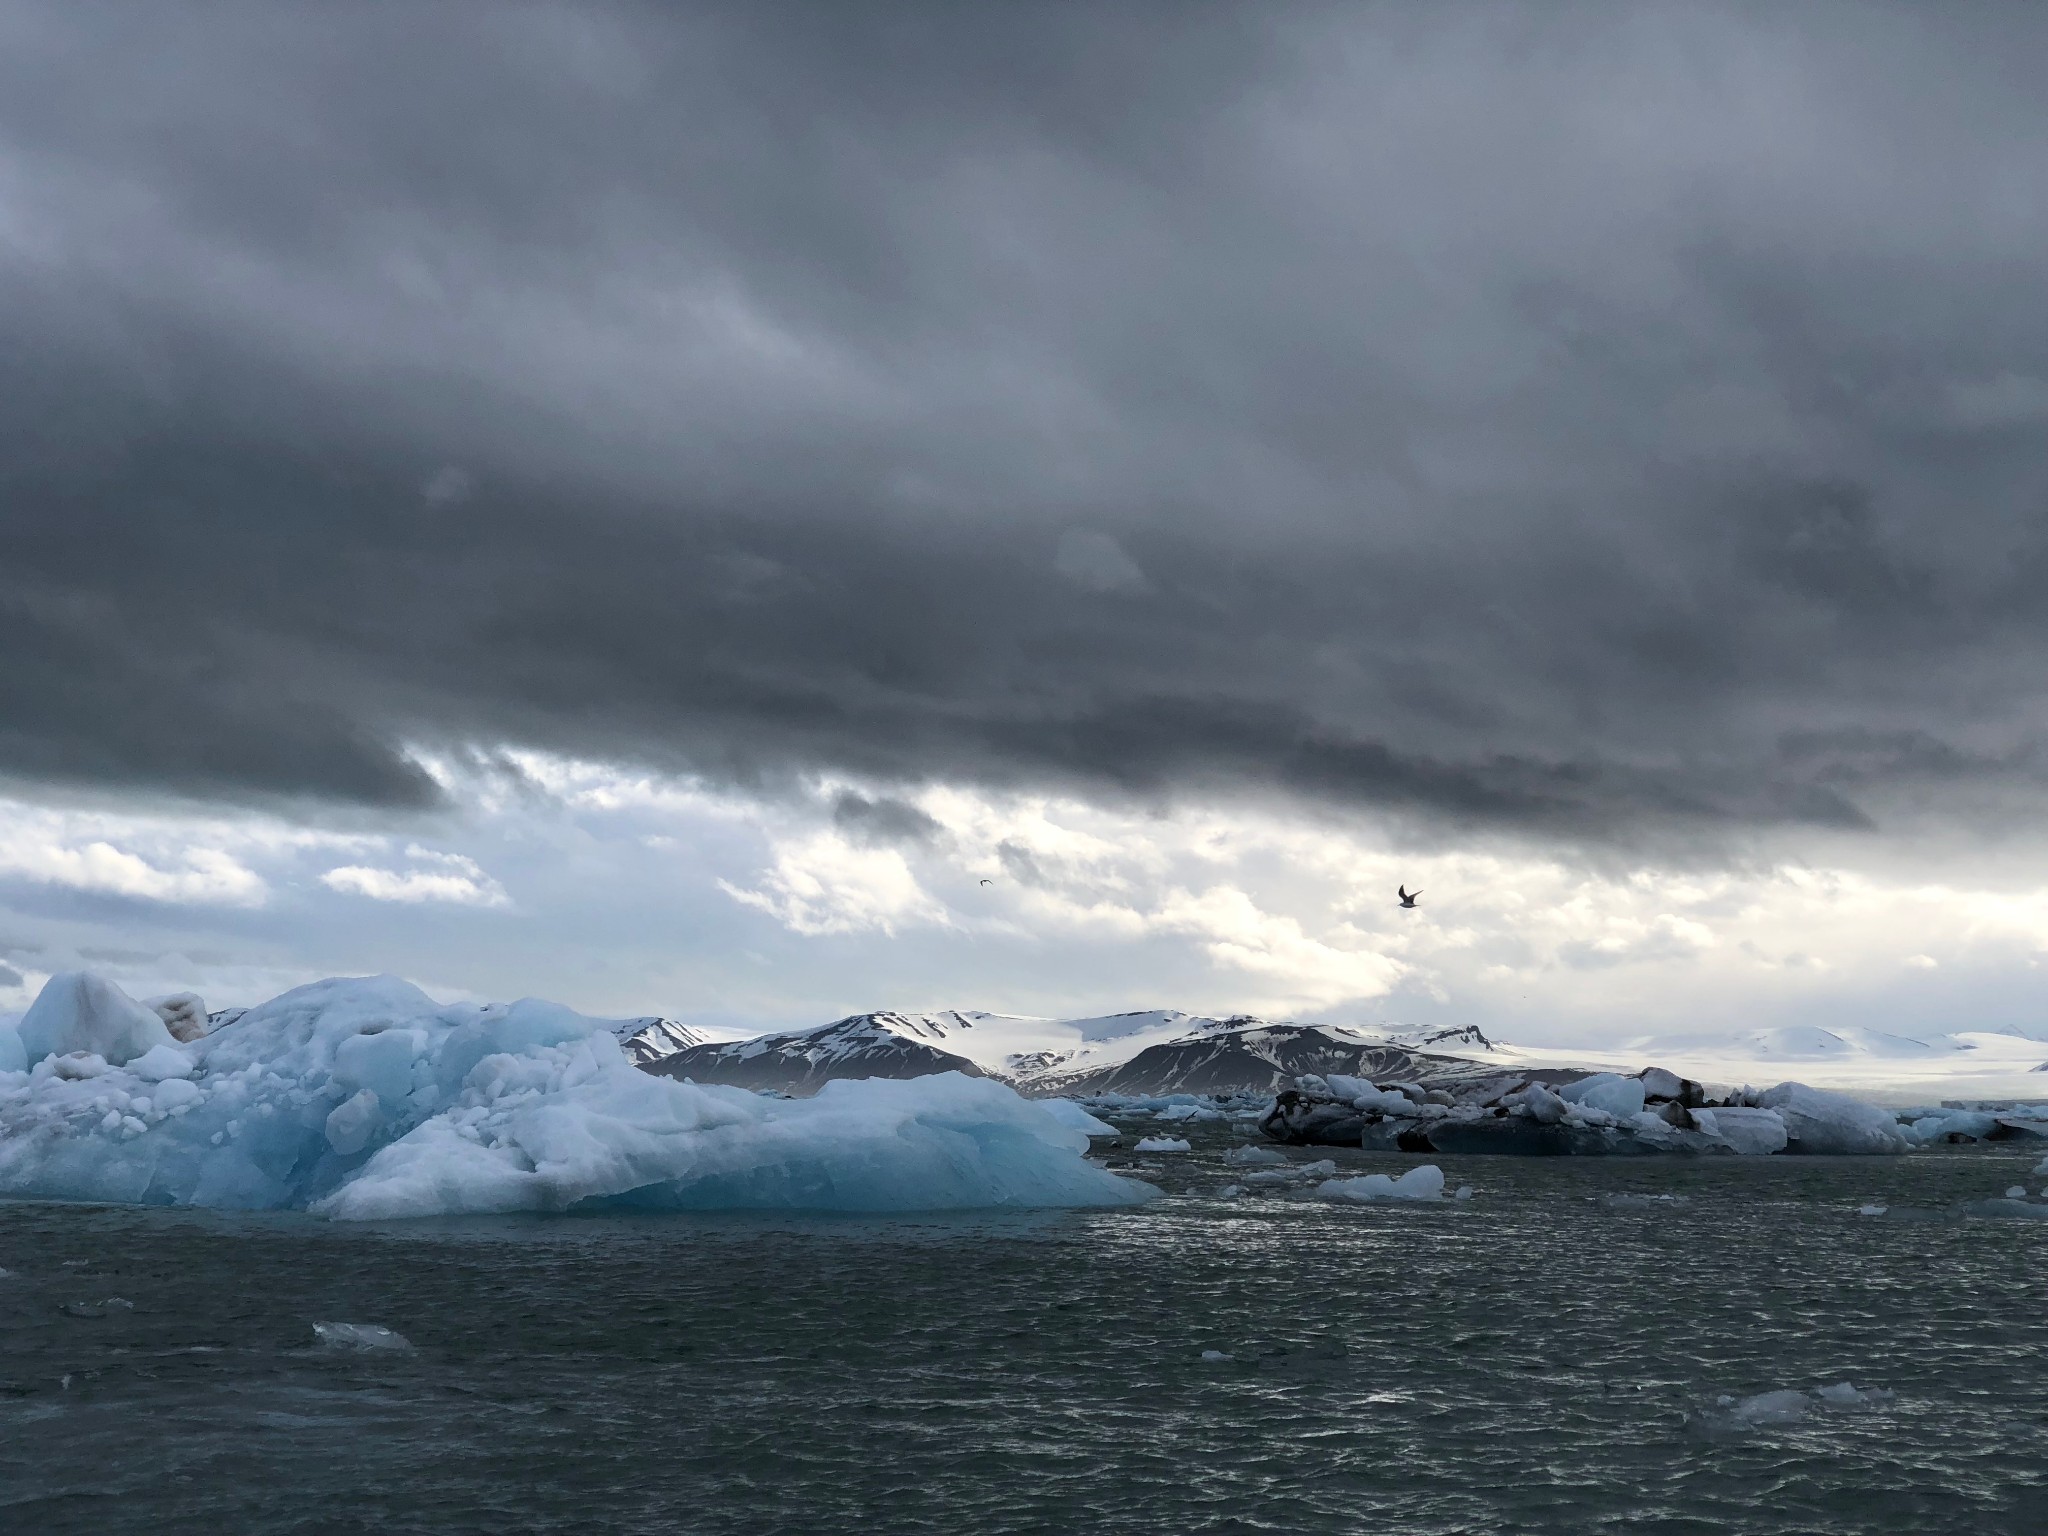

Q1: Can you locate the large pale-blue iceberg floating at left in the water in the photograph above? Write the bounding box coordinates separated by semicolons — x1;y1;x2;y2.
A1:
0;973;1155;1221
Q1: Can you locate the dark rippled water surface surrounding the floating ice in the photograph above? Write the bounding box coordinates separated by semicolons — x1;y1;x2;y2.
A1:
0;1137;2048;1536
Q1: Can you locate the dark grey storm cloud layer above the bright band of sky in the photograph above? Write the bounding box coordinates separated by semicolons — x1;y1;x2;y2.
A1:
0;4;2048;838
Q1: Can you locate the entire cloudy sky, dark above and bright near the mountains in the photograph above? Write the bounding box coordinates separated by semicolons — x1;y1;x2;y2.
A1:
0;0;2048;1042
